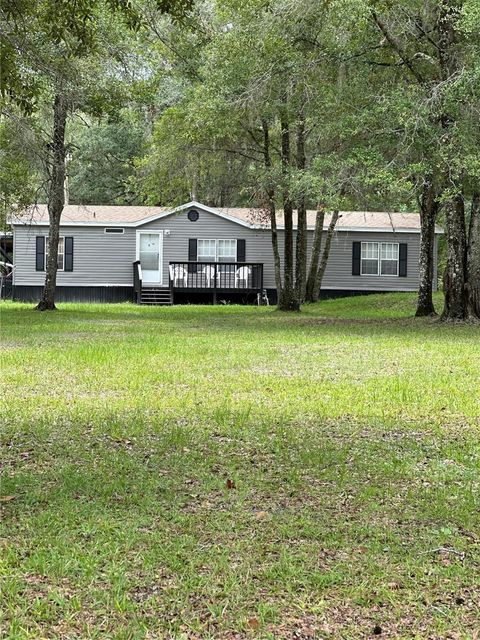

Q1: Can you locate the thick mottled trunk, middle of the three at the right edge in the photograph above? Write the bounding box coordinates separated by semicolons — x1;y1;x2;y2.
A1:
441;194;467;320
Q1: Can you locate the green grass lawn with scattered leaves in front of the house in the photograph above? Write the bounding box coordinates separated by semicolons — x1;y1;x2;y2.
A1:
0;294;480;640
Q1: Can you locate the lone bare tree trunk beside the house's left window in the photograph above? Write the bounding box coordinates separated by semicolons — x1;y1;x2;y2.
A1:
36;94;67;311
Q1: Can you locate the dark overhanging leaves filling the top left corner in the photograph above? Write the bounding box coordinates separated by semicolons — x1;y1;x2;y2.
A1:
0;0;192;113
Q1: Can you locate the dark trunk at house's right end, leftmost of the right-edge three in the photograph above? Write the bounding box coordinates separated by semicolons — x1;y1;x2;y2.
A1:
415;176;438;318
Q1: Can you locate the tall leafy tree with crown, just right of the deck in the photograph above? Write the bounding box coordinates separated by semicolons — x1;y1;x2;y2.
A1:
155;0;364;311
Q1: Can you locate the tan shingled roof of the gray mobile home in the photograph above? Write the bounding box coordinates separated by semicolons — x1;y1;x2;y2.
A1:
11;202;442;233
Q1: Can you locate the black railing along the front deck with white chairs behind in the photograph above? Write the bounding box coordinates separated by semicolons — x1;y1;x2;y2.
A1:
169;262;263;291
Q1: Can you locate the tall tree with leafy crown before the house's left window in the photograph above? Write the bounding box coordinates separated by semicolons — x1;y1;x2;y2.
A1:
0;0;190;311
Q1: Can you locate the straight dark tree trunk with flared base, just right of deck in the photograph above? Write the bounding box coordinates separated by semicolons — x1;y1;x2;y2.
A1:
277;112;300;311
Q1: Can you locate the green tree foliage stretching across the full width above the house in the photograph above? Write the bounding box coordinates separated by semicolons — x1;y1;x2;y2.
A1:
2;0;480;220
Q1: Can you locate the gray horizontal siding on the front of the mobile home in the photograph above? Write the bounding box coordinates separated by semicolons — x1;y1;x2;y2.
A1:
14;210;436;291
